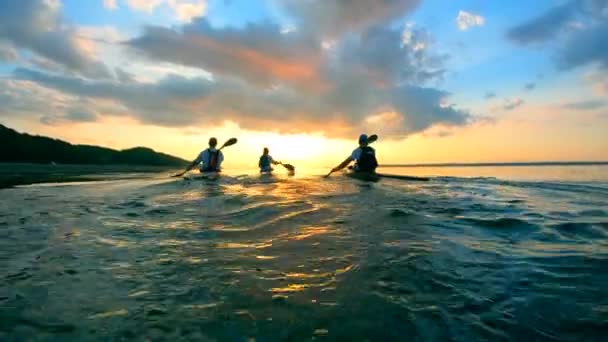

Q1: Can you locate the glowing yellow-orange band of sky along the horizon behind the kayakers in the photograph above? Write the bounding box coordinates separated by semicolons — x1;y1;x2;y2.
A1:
8;99;608;167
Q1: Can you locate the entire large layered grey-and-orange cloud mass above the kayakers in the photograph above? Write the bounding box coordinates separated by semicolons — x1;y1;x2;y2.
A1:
3;0;472;137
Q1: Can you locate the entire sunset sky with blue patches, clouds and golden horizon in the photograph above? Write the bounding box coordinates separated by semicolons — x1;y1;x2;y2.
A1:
0;0;608;166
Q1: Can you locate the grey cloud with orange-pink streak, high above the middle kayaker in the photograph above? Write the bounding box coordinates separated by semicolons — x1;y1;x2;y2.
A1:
127;18;321;85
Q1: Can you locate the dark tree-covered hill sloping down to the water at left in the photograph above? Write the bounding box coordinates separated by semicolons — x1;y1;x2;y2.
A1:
0;124;188;166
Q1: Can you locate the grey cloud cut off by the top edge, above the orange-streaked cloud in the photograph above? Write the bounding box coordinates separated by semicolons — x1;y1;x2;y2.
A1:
278;0;421;38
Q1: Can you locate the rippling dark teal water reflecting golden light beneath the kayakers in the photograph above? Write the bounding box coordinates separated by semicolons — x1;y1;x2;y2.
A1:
0;166;608;341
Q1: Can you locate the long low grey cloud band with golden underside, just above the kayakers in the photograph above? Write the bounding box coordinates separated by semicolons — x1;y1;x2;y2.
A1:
15;63;470;137
